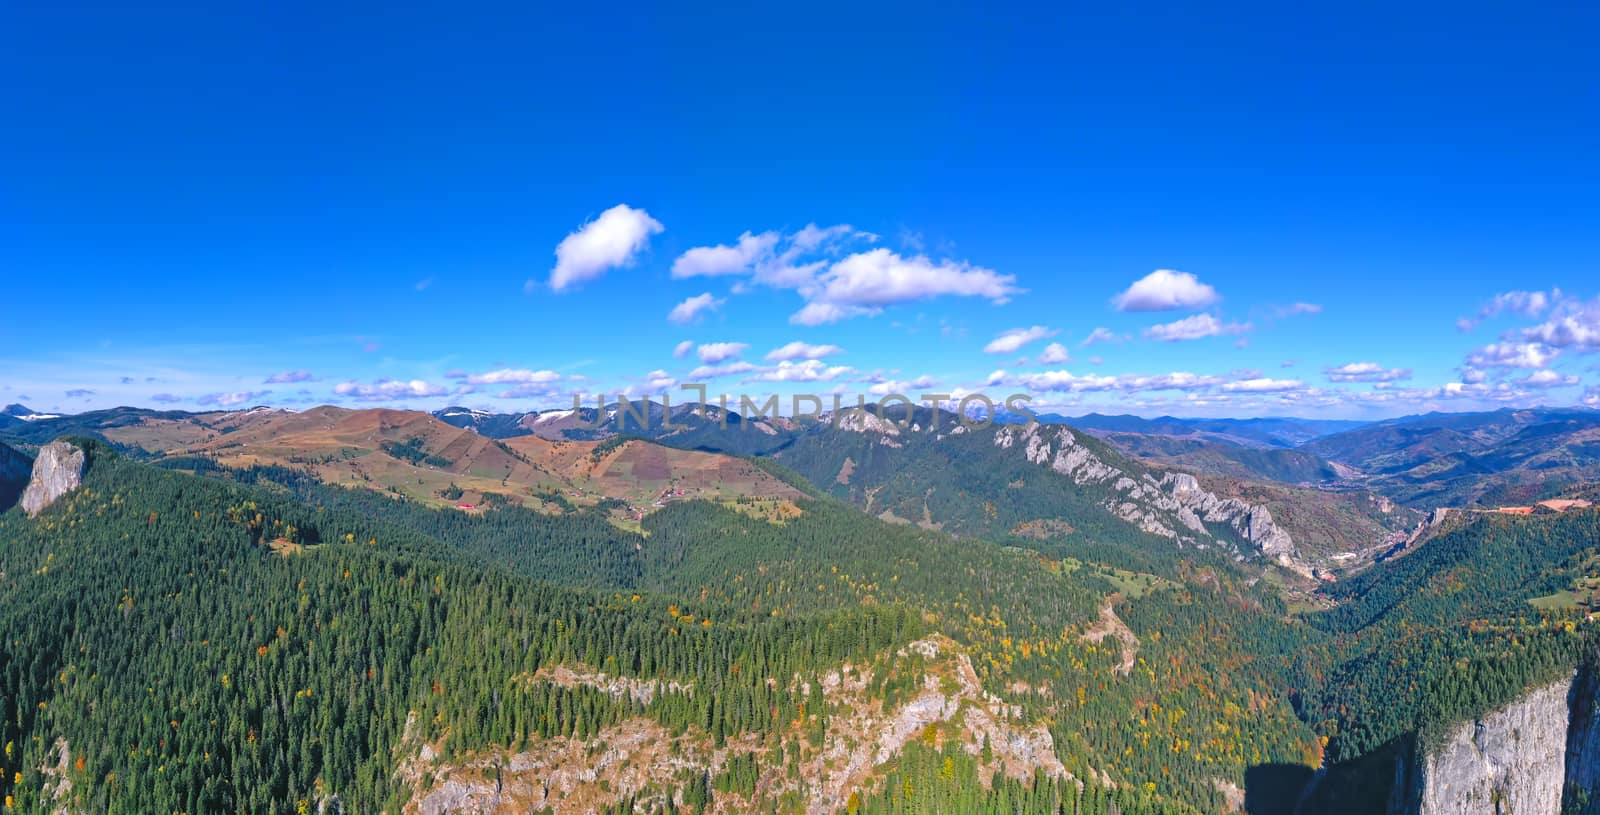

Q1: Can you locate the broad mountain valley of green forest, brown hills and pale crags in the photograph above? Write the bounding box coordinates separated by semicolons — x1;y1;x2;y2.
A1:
0;407;1600;815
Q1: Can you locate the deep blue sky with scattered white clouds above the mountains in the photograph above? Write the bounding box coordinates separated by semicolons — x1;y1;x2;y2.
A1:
0;3;1600;416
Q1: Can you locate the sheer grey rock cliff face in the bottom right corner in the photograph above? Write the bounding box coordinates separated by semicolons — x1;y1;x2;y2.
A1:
1389;671;1600;815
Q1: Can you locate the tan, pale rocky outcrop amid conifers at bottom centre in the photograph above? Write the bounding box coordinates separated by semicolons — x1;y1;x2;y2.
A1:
398;636;1081;815
